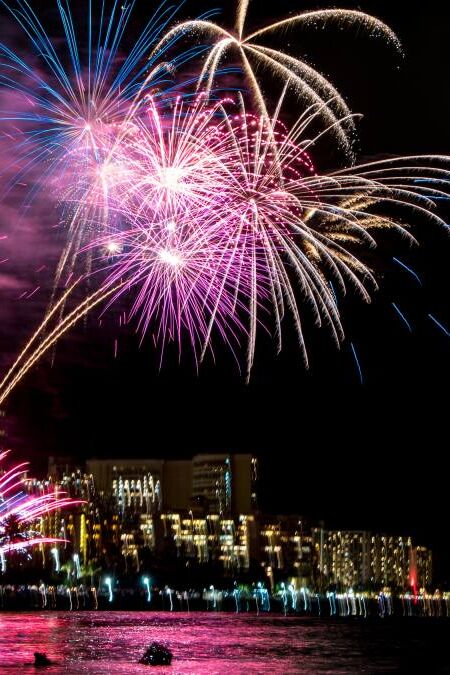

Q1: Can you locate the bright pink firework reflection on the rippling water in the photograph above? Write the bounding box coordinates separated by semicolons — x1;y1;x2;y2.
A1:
0;612;312;675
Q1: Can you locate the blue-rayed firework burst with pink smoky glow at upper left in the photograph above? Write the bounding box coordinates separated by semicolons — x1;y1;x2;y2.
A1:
0;0;211;281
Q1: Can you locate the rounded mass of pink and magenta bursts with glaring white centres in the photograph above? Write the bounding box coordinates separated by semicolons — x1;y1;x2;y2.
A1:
85;97;320;364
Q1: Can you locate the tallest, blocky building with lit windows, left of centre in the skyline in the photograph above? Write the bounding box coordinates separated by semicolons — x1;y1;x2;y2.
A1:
73;455;257;571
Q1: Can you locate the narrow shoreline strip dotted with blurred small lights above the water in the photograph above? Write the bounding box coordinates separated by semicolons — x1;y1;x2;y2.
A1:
0;586;450;620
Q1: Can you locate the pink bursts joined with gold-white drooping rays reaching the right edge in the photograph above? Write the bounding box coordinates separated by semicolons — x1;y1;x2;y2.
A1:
82;97;449;375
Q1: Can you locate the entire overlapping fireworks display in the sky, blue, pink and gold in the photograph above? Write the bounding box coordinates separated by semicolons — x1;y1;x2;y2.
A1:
0;0;449;396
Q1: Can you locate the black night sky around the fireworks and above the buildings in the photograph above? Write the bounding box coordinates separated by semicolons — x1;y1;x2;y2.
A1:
0;0;450;579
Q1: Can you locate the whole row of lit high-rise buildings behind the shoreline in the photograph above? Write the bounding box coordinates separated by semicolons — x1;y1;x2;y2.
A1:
21;454;432;592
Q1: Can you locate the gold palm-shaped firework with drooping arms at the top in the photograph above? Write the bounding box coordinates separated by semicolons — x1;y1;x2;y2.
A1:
151;0;401;152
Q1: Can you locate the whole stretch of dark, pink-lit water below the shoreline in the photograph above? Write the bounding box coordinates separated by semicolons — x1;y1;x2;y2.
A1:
0;611;450;675
